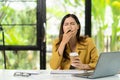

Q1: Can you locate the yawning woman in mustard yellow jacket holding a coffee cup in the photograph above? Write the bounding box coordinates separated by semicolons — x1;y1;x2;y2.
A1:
50;14;98;70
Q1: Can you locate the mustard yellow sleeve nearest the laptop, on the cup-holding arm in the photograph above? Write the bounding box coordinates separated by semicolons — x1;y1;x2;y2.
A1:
88;38;98;68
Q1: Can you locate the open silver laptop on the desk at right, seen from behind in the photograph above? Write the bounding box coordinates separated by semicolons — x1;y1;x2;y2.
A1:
73;52;120;78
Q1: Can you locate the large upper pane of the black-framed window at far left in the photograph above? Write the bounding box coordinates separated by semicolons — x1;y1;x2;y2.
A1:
0;0;37;45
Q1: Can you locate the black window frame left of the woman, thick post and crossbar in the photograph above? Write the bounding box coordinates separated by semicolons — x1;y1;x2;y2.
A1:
0;0;46;69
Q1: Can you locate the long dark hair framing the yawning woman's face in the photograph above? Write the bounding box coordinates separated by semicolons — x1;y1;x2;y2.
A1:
56;14;81;59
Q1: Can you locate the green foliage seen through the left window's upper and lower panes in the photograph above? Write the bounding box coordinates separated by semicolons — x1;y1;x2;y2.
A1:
0;0;37;69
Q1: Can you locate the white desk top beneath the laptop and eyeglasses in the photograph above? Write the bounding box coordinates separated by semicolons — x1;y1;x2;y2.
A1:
0;70;120;80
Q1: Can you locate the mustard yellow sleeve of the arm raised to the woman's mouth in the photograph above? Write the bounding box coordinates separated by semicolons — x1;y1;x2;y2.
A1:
50;39;62;69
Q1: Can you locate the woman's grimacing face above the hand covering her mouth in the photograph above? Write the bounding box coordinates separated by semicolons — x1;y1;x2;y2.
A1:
63;17;79;35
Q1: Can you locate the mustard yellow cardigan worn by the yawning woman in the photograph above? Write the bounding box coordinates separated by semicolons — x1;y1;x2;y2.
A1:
50;37;98;70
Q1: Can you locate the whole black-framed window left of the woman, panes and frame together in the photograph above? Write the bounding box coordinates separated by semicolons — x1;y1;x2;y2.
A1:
0;0;46;69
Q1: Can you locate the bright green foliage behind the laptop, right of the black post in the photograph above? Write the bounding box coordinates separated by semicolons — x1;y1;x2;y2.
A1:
92;0;120;52
